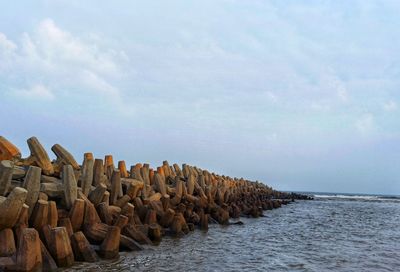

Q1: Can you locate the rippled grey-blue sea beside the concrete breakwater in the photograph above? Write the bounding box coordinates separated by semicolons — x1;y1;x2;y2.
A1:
65;193;400;272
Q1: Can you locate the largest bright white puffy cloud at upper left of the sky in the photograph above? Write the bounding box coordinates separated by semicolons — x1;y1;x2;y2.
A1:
0;19;128;109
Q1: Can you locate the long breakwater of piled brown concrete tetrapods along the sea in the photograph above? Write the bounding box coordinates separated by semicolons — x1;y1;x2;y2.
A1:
0;137;306;271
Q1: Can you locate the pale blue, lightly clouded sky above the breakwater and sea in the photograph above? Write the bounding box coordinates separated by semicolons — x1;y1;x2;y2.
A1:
0;0;400;194
